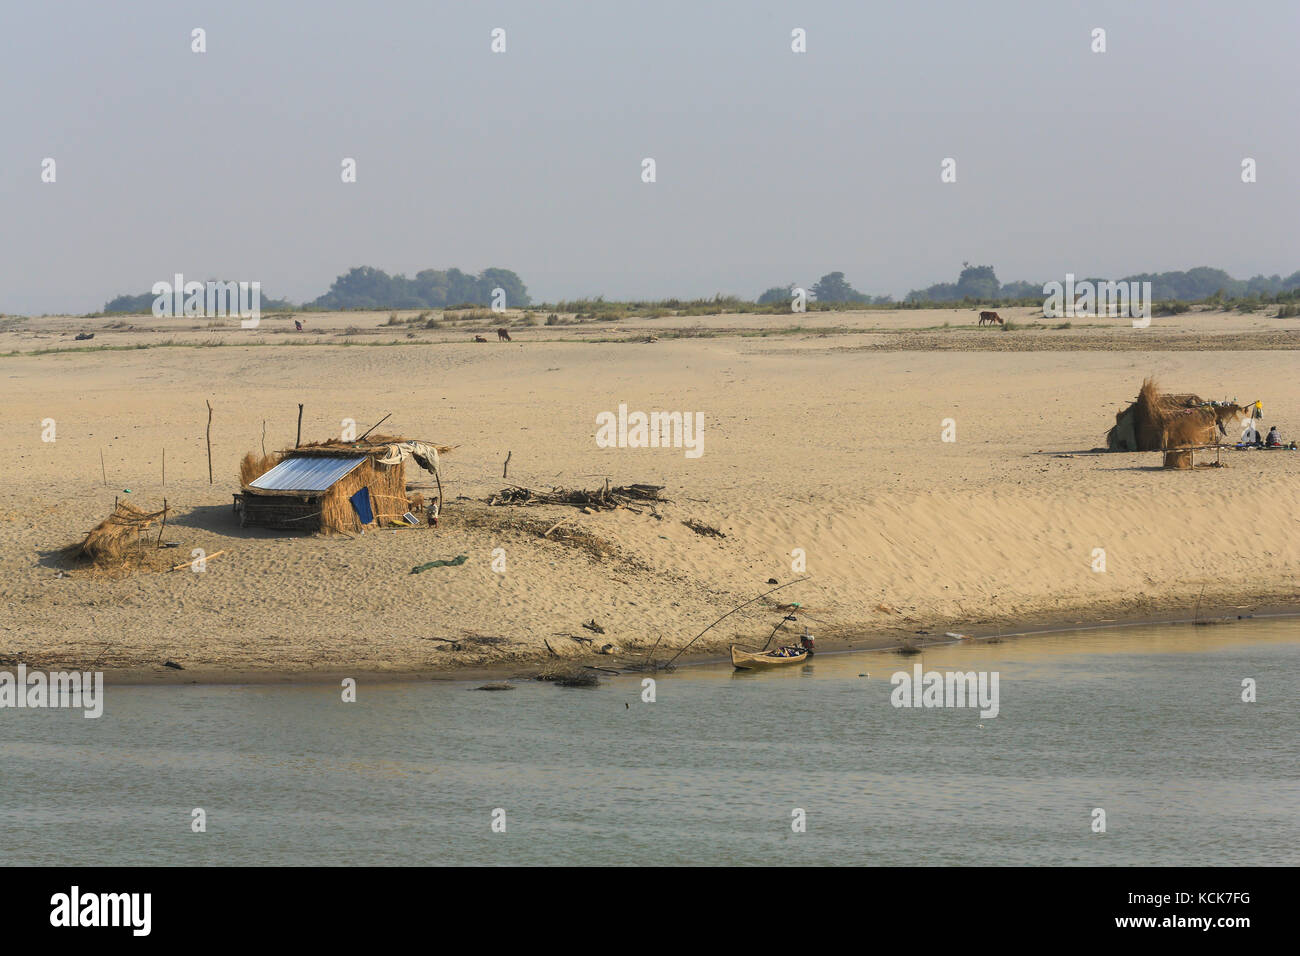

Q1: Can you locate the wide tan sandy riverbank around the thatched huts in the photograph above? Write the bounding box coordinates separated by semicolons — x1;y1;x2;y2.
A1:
0;304;1300;680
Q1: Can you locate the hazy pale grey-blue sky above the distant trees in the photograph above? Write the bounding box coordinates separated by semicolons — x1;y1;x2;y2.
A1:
0;0;1300;313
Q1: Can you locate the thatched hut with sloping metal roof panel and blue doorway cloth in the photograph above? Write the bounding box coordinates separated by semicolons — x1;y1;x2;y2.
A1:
234;434;451;533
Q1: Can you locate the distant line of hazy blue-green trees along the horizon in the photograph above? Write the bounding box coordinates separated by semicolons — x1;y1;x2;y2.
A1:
94;263;1300;313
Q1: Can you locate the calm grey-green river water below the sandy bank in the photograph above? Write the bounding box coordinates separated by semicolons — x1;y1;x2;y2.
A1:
0;620;1300;865
